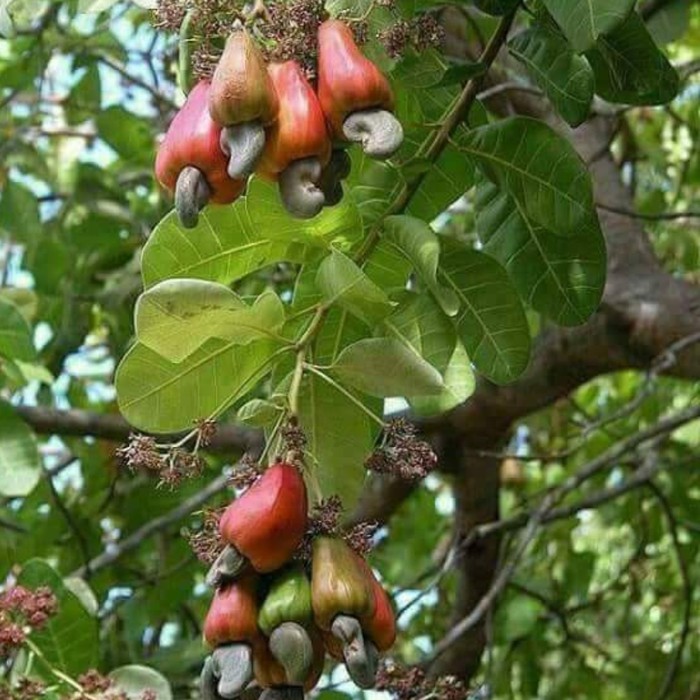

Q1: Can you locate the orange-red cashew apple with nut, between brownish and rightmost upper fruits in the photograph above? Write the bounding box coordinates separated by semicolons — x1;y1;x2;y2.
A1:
257;61;331;219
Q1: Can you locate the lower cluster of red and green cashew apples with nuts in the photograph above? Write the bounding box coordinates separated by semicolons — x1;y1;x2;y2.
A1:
200;462;396;700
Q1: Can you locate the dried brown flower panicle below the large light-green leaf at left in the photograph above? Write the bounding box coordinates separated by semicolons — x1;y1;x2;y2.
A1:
116;433;204;488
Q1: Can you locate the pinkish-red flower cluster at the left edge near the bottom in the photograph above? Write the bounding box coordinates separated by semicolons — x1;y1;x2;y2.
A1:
0;586;58;657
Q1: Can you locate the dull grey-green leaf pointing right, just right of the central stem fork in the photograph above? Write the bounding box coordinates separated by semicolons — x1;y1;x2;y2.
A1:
331;338;443;398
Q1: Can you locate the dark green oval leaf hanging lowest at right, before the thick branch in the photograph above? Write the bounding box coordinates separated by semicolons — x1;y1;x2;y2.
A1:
440;247;530;384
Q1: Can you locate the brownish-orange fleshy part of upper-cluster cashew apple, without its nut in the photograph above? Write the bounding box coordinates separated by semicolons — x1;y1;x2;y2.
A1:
209;29;279;126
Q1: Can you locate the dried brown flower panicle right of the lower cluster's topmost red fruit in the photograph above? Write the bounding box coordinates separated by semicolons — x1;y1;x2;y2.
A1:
365;418;437;481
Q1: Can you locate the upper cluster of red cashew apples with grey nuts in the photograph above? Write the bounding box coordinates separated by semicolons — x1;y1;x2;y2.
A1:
156;19;403;228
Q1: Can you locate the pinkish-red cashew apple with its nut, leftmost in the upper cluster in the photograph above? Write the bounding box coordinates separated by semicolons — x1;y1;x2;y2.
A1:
155;80;245;228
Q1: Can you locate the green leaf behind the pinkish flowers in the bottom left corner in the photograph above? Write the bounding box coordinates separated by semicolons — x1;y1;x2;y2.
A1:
18;559;99;680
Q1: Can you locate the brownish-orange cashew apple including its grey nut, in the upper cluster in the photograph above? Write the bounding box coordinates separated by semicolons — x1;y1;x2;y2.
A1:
209;22;279;178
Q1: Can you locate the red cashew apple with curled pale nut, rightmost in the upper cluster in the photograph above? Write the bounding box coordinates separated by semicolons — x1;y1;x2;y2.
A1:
318;19;403;158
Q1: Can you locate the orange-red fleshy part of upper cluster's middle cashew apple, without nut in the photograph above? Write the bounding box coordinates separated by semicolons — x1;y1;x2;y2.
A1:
258;61;331;180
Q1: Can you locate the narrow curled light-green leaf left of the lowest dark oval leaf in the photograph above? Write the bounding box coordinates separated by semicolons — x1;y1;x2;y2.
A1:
384;216;459;316
